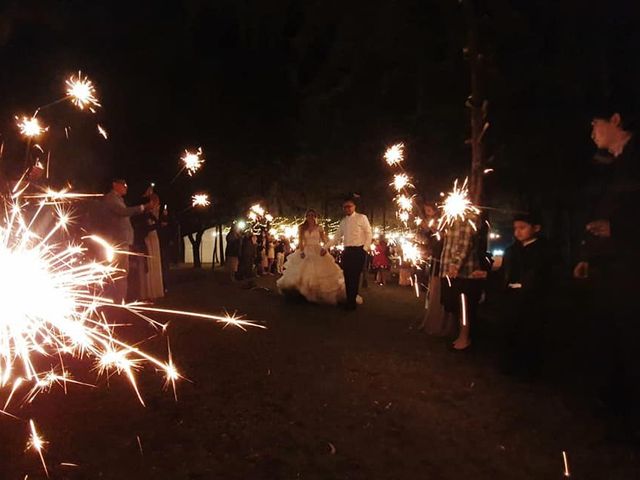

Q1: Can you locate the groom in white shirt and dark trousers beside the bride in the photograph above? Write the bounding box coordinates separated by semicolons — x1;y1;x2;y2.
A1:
326;199;372;310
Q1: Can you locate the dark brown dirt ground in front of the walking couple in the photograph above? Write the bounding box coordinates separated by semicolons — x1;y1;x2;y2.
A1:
0;272;640;480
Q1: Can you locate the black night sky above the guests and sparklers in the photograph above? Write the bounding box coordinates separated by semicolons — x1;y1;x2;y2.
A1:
0;0;640;221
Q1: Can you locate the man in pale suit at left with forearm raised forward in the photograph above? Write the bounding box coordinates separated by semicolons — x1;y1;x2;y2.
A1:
102;178;150;303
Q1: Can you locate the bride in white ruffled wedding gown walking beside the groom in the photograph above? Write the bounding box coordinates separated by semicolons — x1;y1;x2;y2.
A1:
277;210;346;305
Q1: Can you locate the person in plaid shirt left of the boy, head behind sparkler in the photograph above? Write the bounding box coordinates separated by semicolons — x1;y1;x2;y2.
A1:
440;216;487;350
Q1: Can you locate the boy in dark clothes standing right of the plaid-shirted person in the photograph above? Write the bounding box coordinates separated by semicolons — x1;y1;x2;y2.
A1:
501;215;552;377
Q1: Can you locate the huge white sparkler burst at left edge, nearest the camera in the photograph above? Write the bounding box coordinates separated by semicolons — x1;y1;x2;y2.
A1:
0;183;266;474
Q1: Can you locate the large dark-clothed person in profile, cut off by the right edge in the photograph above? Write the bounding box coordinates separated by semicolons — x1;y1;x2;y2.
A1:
574;102;640;442
